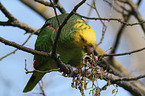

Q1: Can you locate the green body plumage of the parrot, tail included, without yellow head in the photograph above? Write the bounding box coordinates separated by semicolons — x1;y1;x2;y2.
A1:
23;14;86;92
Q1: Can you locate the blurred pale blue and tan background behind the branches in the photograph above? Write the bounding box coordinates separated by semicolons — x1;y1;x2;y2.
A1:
0;0;145;96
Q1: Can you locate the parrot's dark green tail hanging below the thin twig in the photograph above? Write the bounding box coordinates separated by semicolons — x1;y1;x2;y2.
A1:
23;71;45;93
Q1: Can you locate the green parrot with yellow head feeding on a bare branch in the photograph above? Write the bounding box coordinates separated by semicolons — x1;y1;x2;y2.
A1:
23;13;96;93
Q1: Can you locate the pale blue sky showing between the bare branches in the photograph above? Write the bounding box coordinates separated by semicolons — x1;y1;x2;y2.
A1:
0;0;145;96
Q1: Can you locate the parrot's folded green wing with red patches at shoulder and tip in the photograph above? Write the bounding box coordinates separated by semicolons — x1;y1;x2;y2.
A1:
34;24;55;69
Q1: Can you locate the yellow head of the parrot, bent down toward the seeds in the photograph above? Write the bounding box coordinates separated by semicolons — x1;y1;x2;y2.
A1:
73;20;96;54
